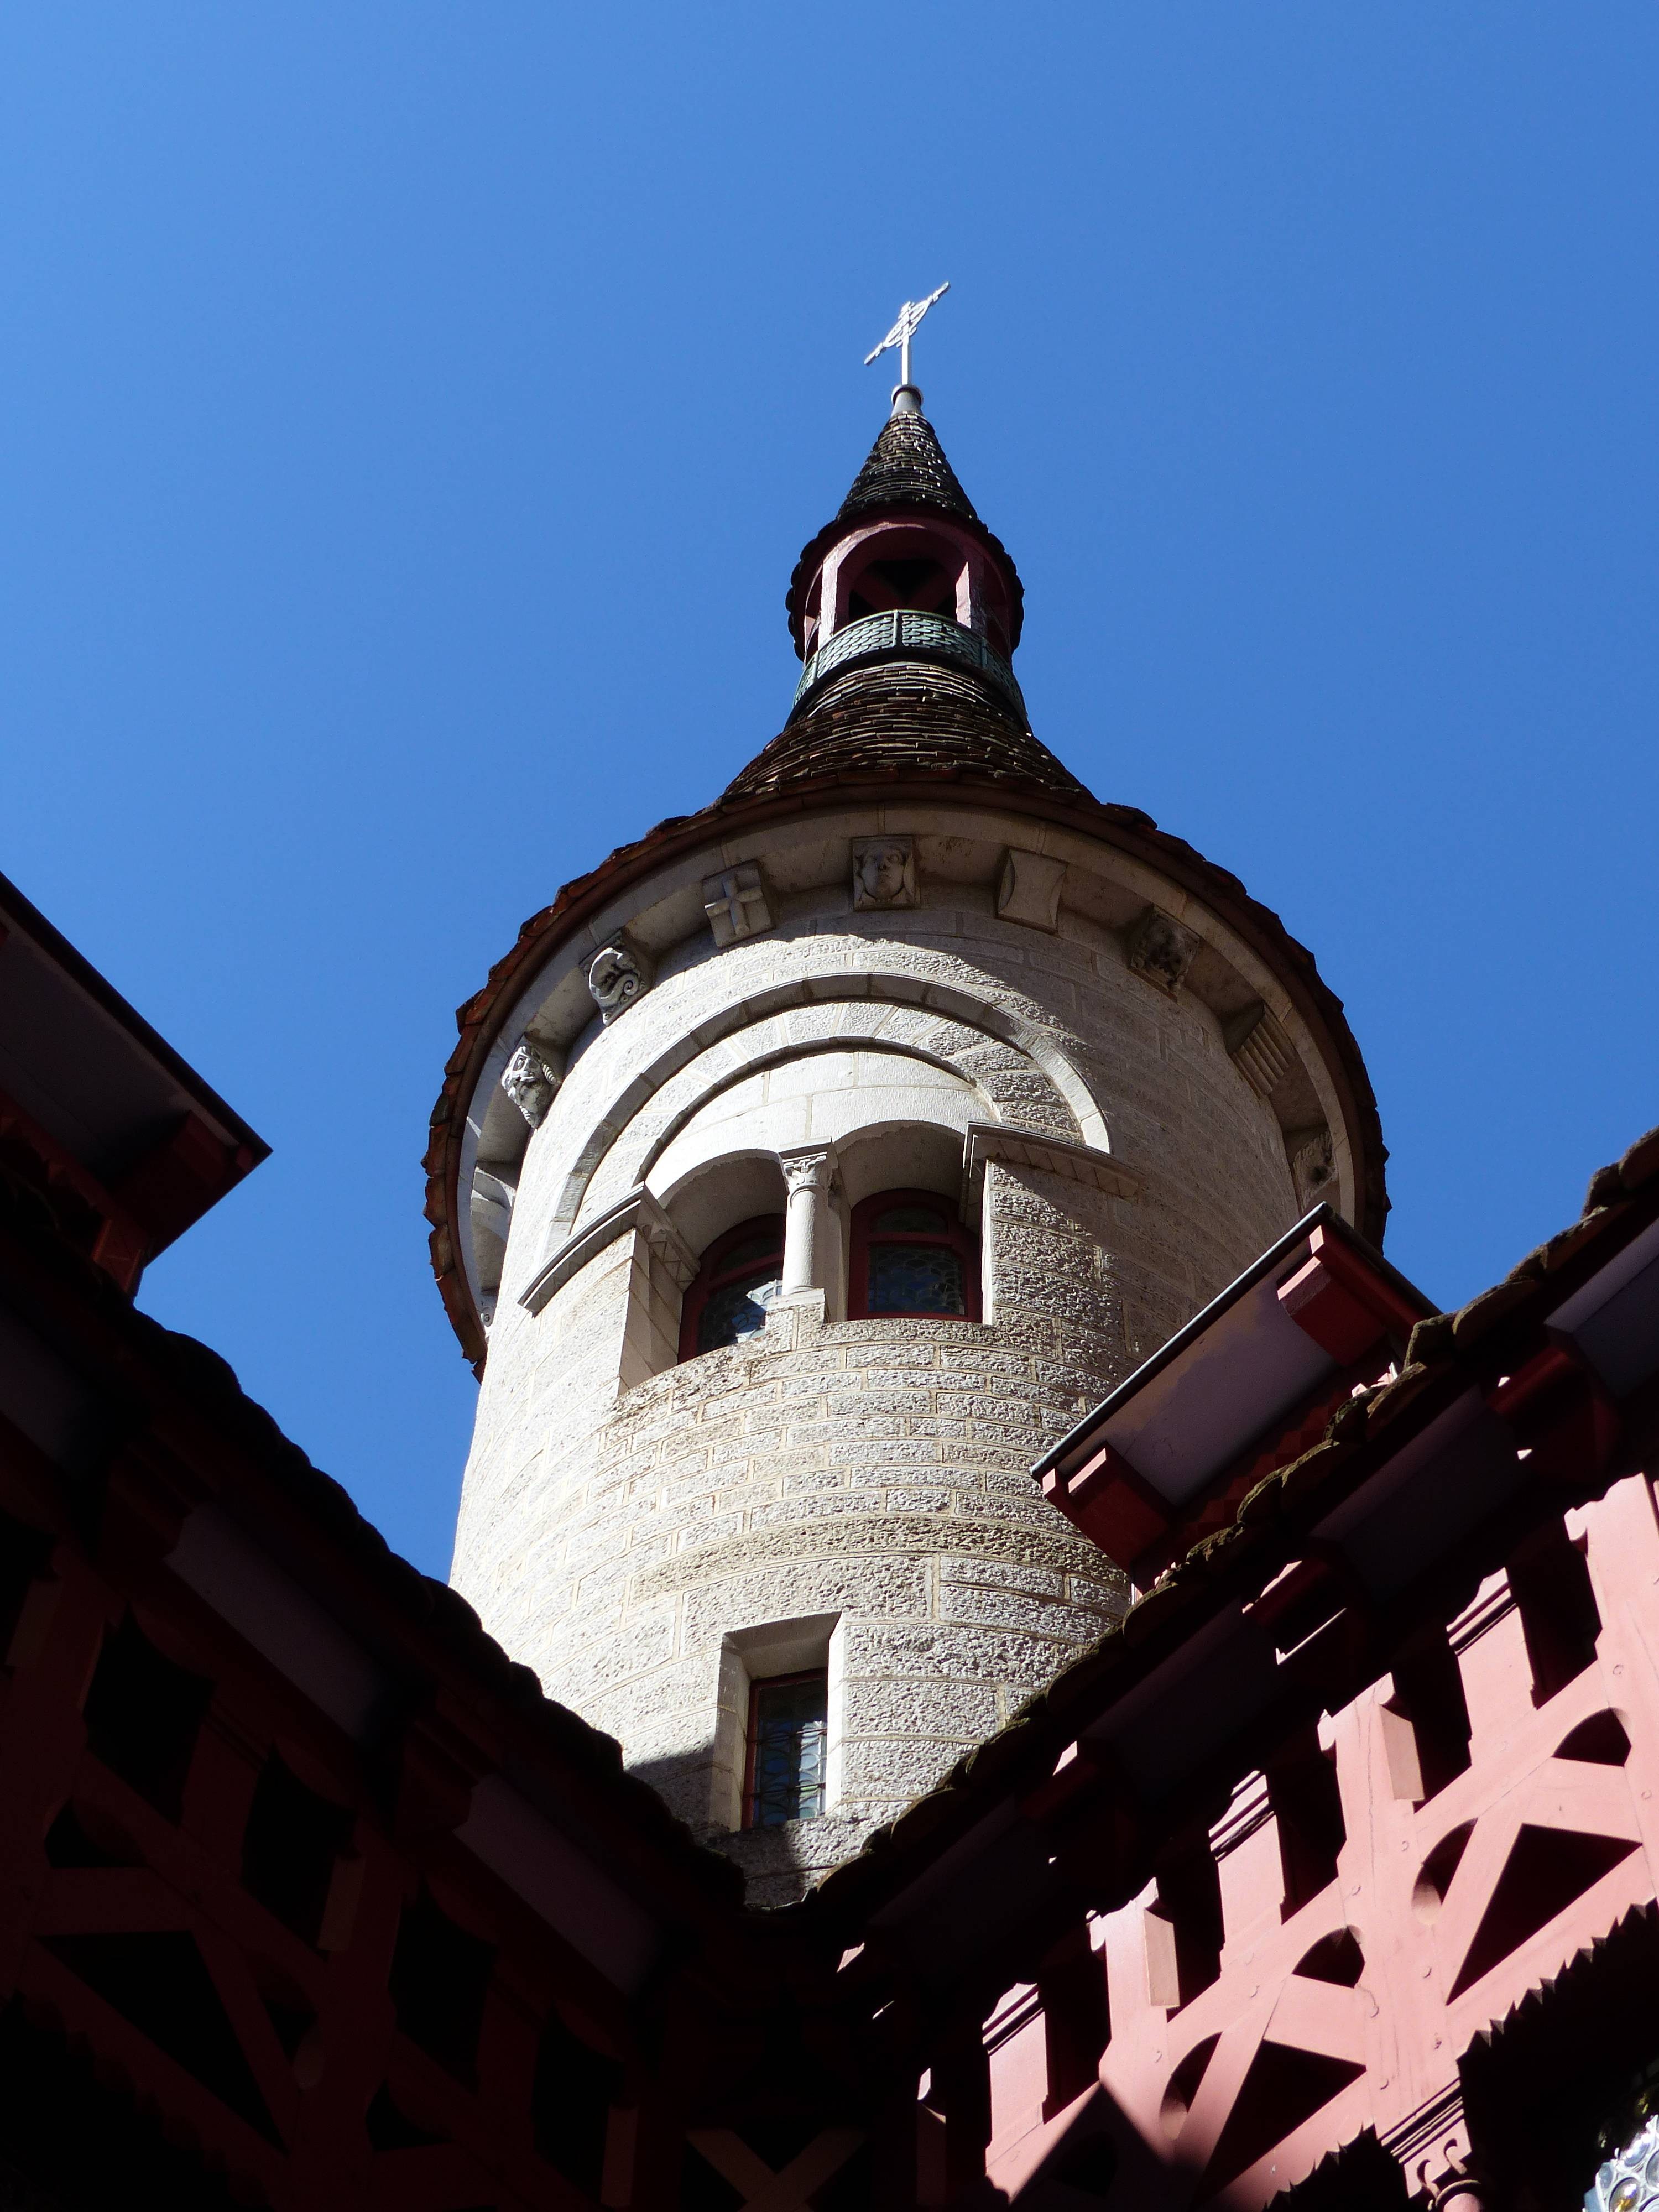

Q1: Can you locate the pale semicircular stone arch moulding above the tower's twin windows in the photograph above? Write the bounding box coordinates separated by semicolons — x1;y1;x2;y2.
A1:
549;975;1093;1243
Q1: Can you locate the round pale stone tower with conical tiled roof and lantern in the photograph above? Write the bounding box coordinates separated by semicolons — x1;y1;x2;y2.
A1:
429;385;1387;1902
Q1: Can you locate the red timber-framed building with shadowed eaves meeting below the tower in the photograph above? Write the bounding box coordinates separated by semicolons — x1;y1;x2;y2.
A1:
0;880;1659;2212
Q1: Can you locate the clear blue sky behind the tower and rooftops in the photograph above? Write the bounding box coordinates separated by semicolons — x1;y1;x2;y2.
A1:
0;0;1659;1571
